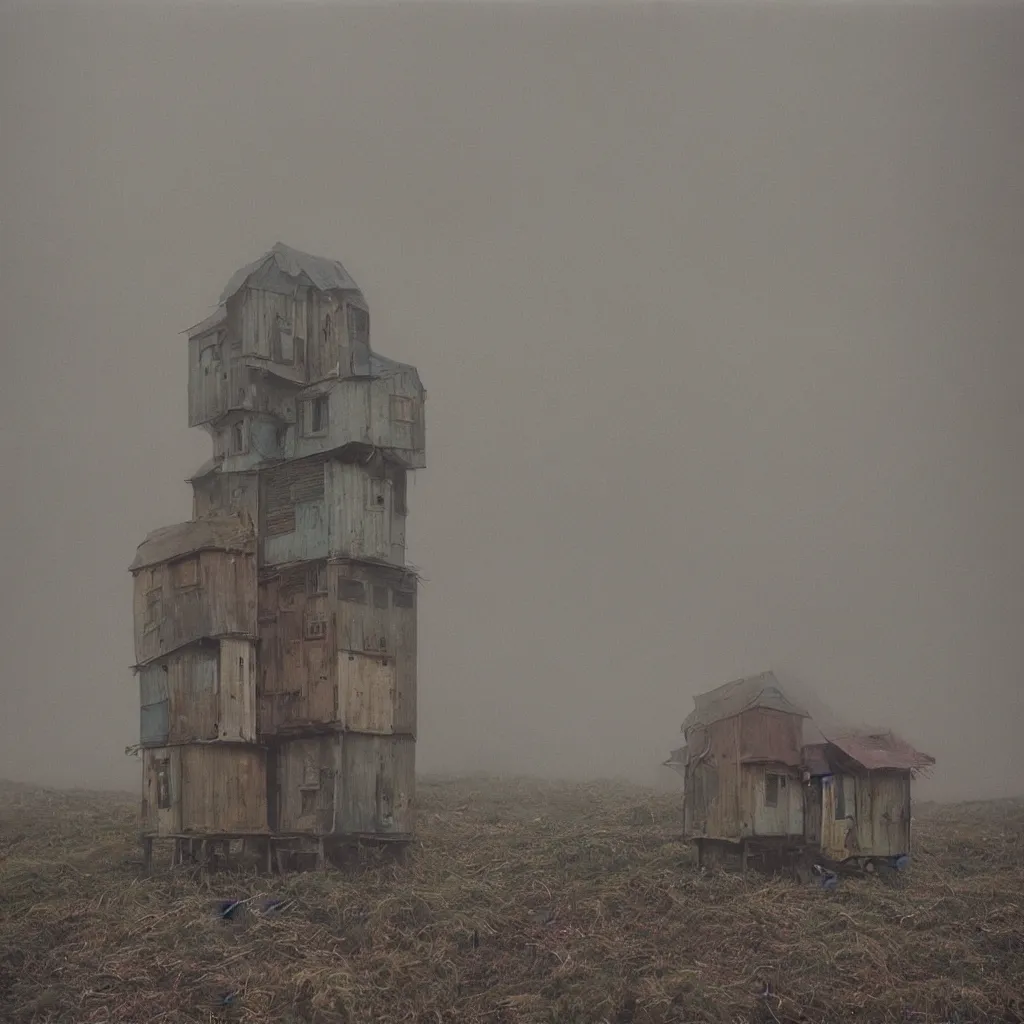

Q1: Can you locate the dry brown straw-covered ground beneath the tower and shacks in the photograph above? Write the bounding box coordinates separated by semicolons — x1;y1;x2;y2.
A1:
0;779;1024;1024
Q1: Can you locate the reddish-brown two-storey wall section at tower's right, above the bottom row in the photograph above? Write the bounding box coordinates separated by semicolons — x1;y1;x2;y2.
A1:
259;560;417;735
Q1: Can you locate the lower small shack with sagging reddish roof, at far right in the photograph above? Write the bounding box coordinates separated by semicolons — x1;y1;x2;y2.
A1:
804;732;935;870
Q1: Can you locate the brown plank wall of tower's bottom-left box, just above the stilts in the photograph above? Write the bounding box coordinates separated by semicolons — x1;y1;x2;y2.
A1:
141;743;267;836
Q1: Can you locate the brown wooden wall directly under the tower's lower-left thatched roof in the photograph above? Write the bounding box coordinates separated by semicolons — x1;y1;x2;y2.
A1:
134;551;256;665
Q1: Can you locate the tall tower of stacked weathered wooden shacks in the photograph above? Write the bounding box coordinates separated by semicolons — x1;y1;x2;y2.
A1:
131;244;425;853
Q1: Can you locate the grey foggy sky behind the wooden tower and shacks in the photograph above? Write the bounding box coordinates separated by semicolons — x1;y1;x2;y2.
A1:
0;3;1024;798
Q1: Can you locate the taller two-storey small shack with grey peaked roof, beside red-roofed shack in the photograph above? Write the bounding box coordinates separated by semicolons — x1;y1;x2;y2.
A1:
674;672;807;863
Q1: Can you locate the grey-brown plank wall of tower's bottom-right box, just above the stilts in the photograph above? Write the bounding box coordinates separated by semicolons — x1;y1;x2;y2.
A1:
271;732;416;837
